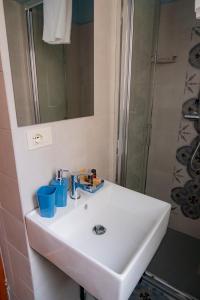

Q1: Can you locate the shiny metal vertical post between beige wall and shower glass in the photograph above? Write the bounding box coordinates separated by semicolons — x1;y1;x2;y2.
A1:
116;0;134;186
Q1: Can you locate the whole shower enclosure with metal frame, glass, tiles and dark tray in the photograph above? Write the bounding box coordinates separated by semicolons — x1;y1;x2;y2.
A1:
117;0;200;299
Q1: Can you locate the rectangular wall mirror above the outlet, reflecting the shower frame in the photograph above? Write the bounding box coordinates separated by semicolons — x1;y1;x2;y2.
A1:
4;0;94;126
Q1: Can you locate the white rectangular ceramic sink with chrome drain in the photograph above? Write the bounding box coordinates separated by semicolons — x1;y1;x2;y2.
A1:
26;182;170;300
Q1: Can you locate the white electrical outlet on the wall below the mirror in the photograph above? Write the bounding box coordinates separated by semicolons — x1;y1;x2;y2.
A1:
27;127;52;150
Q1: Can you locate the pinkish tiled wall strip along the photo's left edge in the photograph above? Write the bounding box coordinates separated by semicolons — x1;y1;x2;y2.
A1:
0;56;33;300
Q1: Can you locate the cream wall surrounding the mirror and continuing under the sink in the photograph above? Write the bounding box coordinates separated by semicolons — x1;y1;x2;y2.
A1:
0;0;120;300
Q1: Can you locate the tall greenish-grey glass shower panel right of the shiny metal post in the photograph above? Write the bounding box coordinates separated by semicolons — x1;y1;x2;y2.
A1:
125;0;159;193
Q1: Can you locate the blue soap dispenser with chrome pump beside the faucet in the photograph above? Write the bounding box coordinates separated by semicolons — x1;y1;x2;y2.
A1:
51;169;68;207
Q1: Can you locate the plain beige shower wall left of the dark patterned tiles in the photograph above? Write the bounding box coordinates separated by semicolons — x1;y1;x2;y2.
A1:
146;0;200;238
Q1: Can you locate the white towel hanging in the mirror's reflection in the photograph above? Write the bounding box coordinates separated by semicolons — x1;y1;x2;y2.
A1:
43;0;72;44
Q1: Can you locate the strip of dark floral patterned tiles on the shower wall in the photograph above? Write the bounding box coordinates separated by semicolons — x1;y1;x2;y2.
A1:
171;25;200;220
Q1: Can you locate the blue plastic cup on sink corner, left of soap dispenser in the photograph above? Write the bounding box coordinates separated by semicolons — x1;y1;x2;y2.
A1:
37;185;56;218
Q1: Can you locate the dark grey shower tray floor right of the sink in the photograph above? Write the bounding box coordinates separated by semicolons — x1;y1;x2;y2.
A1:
147;229;200;299
